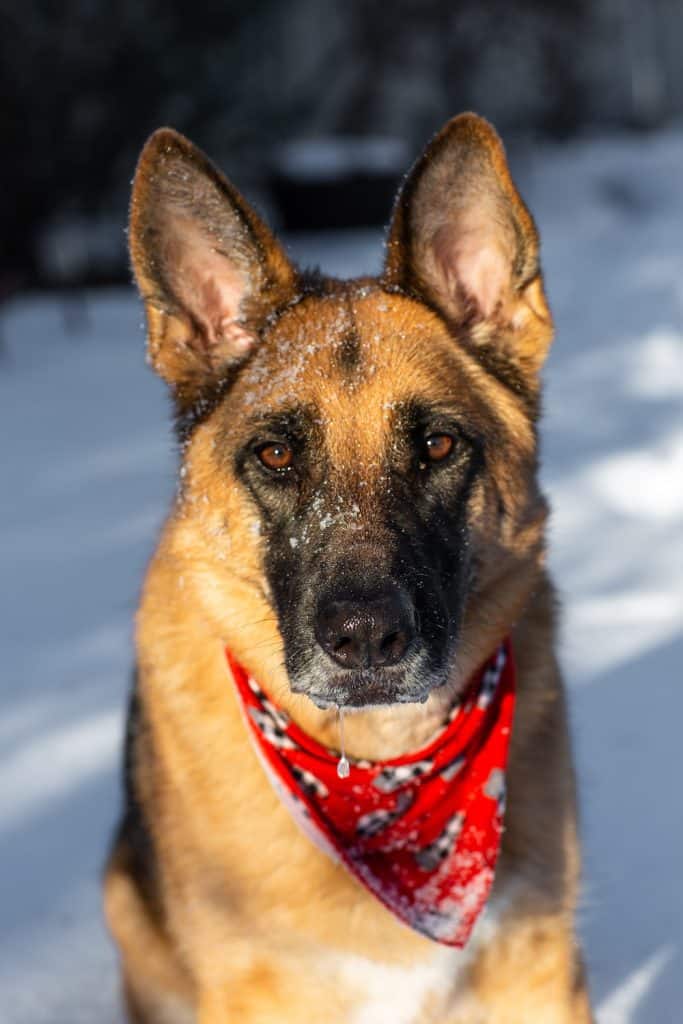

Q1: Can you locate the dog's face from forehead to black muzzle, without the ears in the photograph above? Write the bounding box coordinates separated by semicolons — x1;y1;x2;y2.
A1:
227;290;493;706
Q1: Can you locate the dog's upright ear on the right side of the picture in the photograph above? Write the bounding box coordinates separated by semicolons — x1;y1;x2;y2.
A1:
384;114;552;373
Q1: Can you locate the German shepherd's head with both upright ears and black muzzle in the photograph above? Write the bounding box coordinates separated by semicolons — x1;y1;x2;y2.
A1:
131;115;552;707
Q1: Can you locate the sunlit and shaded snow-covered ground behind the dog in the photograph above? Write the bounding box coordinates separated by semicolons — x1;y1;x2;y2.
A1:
0;135;683;1024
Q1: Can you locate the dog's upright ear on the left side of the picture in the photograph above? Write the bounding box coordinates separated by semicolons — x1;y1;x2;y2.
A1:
130;128;296;400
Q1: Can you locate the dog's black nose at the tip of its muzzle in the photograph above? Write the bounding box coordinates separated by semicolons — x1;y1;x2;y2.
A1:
315;589;415;669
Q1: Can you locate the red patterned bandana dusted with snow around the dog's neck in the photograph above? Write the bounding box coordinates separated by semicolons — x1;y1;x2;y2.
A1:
226;639;515;947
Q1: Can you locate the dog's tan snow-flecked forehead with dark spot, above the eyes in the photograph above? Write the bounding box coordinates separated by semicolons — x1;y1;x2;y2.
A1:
240;288;464;444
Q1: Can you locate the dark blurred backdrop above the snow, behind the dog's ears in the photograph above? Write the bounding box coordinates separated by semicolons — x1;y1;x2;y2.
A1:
0;0;683;301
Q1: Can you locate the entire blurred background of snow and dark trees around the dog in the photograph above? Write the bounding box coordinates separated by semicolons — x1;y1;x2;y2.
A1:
0;0;683;1024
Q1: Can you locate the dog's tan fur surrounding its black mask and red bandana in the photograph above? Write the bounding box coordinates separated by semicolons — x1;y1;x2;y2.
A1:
105;114;592;1024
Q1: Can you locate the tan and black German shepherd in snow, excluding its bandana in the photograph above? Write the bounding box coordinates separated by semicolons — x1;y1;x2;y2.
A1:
104;114;592;1024
